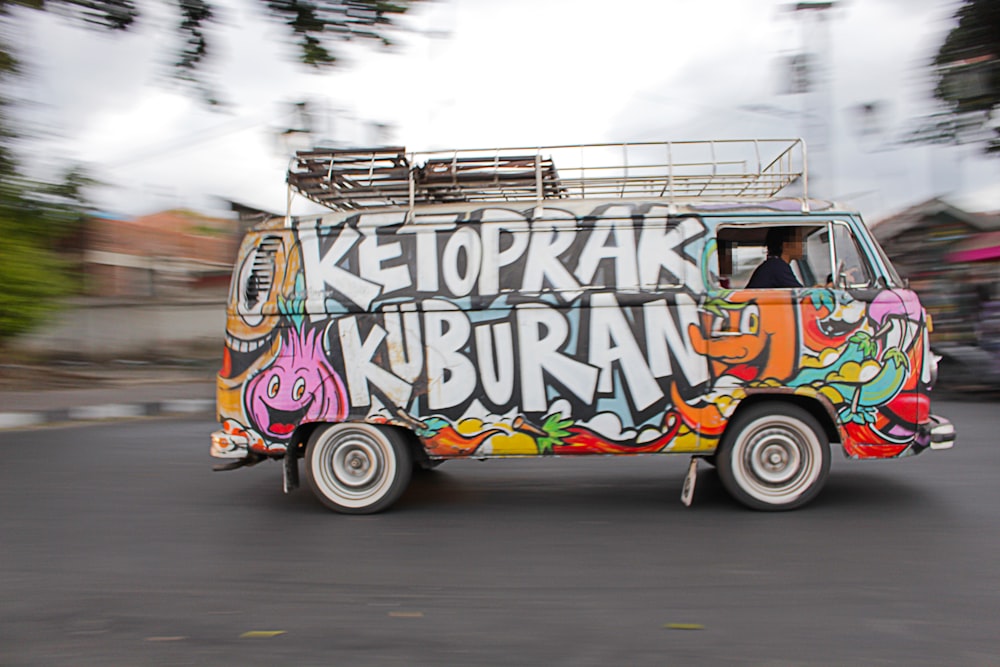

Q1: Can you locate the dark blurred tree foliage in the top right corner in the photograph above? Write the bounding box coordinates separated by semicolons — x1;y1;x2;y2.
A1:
918;0;1000;155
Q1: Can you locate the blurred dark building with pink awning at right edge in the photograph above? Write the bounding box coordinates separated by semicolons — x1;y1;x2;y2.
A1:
872;199;1000;345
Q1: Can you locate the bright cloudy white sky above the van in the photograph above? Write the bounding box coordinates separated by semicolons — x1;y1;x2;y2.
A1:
7;0;1000;222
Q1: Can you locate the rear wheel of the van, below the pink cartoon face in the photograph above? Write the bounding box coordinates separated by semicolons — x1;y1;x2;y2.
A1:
305;424;413;514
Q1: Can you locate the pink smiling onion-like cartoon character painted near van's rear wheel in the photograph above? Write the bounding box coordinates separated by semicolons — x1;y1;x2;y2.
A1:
244;329;348;441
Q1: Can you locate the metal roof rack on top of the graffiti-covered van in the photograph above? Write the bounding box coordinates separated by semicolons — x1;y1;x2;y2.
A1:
288;139;808;211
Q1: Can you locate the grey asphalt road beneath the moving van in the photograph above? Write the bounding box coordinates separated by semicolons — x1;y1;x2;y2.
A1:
0;402;1000;666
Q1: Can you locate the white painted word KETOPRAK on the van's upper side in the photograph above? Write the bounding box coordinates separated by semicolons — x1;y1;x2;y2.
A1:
299;207;703;312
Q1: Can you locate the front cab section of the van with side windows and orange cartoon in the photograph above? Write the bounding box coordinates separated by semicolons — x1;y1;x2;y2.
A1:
702;218;928;457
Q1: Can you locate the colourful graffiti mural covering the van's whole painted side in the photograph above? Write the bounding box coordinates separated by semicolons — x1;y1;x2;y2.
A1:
220;203;927;464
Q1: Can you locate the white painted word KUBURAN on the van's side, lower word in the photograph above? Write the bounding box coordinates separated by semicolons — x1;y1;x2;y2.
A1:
332;292;709;420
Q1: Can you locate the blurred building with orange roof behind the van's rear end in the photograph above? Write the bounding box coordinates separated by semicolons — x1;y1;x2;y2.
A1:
81;209;241;298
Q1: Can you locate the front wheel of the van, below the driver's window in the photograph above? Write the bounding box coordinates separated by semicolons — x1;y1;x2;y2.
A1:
716;402;830;511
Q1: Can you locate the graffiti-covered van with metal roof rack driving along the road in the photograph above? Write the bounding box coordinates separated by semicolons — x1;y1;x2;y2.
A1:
211;140;954;513
